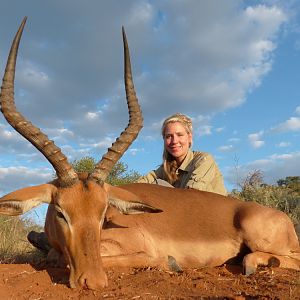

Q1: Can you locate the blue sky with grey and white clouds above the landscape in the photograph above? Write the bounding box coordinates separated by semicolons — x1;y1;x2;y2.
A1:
0;0;300;214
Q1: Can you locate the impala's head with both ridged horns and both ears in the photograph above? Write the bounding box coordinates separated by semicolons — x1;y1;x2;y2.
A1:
0;18;160;289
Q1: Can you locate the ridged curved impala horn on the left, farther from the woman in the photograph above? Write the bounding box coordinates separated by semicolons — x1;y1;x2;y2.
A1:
0;17;78;186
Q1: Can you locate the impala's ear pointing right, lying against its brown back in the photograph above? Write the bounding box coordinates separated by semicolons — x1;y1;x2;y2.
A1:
108;198;162;215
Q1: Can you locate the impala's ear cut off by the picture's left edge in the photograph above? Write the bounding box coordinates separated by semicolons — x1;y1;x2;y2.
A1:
0;184;57;216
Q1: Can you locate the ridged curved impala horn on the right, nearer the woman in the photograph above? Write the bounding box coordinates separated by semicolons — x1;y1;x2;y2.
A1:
89;27;143;183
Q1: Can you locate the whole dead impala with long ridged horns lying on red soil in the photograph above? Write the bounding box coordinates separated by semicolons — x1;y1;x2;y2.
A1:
0;19;300;290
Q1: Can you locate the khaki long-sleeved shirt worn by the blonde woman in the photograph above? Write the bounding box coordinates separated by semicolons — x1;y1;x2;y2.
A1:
137;150;227;196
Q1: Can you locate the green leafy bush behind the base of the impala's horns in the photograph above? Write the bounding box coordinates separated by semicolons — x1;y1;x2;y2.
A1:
72;156;141;185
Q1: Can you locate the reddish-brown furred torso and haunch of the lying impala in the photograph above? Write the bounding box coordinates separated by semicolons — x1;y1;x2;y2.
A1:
102;184;300;268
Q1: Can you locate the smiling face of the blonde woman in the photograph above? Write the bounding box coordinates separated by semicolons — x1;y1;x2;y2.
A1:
164;122;192;164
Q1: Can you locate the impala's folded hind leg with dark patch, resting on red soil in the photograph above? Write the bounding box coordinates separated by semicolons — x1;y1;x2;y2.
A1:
243;251;300;275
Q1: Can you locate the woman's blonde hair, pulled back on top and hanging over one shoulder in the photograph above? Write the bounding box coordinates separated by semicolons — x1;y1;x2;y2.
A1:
161;113;193;184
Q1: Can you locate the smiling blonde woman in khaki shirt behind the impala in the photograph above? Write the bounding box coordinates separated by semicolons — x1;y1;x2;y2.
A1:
137;113;227;195
